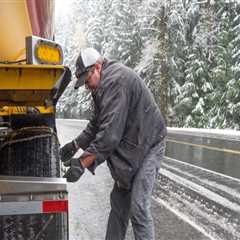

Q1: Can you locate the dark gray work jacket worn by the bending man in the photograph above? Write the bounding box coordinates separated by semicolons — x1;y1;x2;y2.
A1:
76;61;167;188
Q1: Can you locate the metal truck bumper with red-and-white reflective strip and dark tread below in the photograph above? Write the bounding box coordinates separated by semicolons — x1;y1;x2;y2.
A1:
0;176;68;240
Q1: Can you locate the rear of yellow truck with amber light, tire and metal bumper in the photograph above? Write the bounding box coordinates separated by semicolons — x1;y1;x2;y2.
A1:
0;0;71;240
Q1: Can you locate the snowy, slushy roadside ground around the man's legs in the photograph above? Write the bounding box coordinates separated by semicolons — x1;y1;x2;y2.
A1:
57;120;240;240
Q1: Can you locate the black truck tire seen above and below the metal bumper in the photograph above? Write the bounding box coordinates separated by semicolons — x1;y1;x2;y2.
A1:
0;123;66;240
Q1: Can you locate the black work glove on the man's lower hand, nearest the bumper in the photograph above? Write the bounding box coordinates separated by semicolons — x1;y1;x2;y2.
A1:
63;158;85;182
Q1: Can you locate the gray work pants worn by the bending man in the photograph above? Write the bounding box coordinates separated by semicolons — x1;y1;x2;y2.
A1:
105;142;165;240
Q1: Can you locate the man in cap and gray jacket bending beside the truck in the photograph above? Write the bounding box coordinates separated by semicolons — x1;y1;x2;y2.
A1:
60;48;166;240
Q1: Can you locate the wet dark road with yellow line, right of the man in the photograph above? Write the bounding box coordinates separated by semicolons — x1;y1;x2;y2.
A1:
166;128;240;178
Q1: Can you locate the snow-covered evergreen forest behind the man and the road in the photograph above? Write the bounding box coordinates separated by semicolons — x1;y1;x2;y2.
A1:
56;0;240;130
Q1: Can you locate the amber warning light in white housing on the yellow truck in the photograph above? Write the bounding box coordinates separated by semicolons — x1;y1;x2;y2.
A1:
26;36;63;65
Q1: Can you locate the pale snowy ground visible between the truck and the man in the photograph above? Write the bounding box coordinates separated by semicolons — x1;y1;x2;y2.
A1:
57;120;112;240
